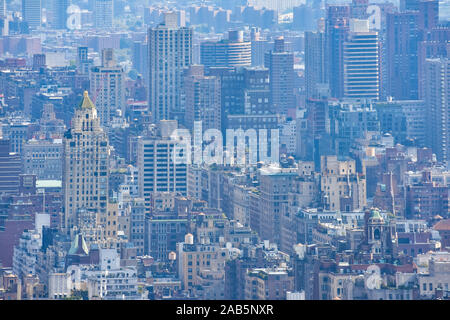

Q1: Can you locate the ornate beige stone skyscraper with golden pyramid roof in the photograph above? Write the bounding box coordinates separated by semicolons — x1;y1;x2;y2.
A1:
63;91;109;232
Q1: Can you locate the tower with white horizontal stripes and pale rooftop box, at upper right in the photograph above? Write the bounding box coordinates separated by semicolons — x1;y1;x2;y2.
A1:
344;19;380;100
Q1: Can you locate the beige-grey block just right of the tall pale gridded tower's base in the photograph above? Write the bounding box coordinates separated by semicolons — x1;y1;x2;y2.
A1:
184;65;221;132
